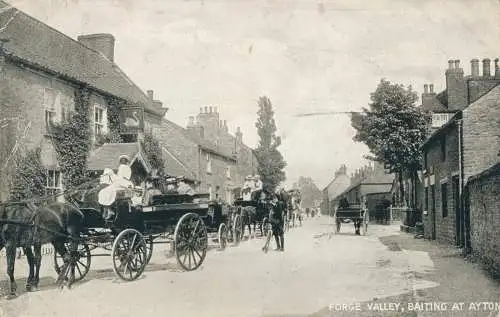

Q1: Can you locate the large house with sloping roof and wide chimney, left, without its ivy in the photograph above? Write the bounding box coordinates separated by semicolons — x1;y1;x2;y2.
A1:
0;1;166;200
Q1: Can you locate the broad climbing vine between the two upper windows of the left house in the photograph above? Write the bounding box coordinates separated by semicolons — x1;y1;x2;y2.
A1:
51;88;92;188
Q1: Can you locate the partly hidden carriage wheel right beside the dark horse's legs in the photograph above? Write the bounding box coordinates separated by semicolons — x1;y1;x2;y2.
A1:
54;242;91;282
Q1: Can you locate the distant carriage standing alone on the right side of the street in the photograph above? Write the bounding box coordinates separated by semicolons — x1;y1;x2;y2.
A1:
333;204;369;235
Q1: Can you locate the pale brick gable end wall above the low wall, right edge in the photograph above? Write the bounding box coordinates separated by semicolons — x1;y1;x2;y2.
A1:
463;86;500;180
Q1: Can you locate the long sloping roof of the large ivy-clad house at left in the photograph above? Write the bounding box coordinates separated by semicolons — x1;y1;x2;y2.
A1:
0;0;164;114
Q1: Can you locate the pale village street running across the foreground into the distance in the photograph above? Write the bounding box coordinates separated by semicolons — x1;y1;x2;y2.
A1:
0;216;500;317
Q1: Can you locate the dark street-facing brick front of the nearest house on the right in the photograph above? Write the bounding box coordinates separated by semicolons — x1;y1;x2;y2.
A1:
422;125;459;244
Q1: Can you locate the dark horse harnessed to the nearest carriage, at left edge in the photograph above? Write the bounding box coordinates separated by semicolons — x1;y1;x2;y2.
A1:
0;202;83;298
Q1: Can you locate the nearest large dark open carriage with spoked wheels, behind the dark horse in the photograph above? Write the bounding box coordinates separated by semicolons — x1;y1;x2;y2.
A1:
50;183;228;281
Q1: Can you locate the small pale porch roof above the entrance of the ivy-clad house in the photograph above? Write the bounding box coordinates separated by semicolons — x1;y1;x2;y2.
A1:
87;143;151;171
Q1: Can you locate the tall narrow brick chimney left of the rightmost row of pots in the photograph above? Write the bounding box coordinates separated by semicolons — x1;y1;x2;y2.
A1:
445;60;468;110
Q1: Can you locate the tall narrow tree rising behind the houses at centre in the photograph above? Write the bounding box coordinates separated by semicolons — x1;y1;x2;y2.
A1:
255;96;286;191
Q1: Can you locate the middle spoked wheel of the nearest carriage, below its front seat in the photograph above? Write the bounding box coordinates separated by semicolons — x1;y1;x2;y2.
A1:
111;229;148;281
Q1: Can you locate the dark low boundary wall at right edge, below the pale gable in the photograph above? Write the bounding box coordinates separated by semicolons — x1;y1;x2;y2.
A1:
466;164;500;275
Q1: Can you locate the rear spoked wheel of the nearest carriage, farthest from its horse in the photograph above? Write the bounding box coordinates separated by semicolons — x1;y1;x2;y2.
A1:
174;213;208;271
